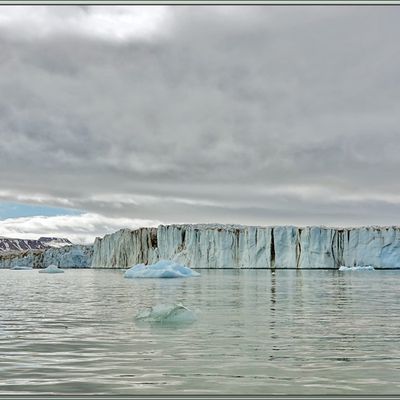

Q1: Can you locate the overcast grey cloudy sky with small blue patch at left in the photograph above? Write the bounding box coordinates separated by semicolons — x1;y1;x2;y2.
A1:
0;6;400;243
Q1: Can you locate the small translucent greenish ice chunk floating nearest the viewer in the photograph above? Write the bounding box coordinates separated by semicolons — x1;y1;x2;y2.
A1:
136;303;196;324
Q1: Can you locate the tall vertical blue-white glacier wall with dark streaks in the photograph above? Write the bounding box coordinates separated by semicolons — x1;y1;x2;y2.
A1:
92;224;400;269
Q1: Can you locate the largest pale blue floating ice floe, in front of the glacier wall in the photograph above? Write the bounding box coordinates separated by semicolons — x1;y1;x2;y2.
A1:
124;260;200;278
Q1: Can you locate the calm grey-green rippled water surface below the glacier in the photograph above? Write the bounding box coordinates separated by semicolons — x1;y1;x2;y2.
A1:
0;270;400;394
